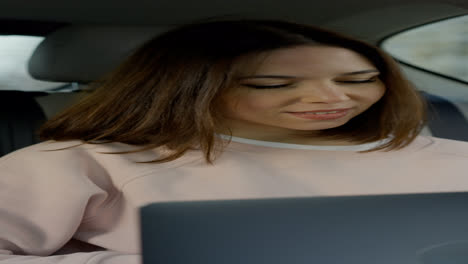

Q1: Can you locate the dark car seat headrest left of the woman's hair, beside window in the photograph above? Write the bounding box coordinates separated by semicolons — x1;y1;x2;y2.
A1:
28;26;167;83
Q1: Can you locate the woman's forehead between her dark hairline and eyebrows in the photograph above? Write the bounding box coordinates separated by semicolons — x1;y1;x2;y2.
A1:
247;46;376;78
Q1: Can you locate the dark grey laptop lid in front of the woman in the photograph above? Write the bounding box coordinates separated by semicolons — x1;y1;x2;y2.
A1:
140;192;468;264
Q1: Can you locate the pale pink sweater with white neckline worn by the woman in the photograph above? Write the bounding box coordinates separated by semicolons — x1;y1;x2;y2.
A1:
0;136;468;264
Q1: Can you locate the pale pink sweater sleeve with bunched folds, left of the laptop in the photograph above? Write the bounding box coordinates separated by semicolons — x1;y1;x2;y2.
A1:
0;144;141;264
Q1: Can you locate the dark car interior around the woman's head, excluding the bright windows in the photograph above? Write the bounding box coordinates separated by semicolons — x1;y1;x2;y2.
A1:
0;0;468;157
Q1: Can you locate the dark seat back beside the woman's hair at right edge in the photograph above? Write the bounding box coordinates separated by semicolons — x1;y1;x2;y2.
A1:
420;91;468;142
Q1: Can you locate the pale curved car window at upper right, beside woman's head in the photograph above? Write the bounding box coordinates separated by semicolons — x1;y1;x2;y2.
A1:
382;15;468;82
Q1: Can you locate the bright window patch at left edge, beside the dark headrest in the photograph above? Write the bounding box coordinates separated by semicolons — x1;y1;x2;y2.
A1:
0;35;64;91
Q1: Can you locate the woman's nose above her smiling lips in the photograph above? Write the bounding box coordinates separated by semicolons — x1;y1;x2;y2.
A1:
300;83;349;103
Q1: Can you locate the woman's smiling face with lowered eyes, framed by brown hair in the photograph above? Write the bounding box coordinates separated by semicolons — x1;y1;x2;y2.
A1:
221;46;385;143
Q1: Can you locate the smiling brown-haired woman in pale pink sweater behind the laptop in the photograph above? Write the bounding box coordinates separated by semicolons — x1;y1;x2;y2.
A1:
0;19;468;264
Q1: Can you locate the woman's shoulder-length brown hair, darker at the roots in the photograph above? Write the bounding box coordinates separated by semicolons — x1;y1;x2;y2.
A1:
39;15;427;164
